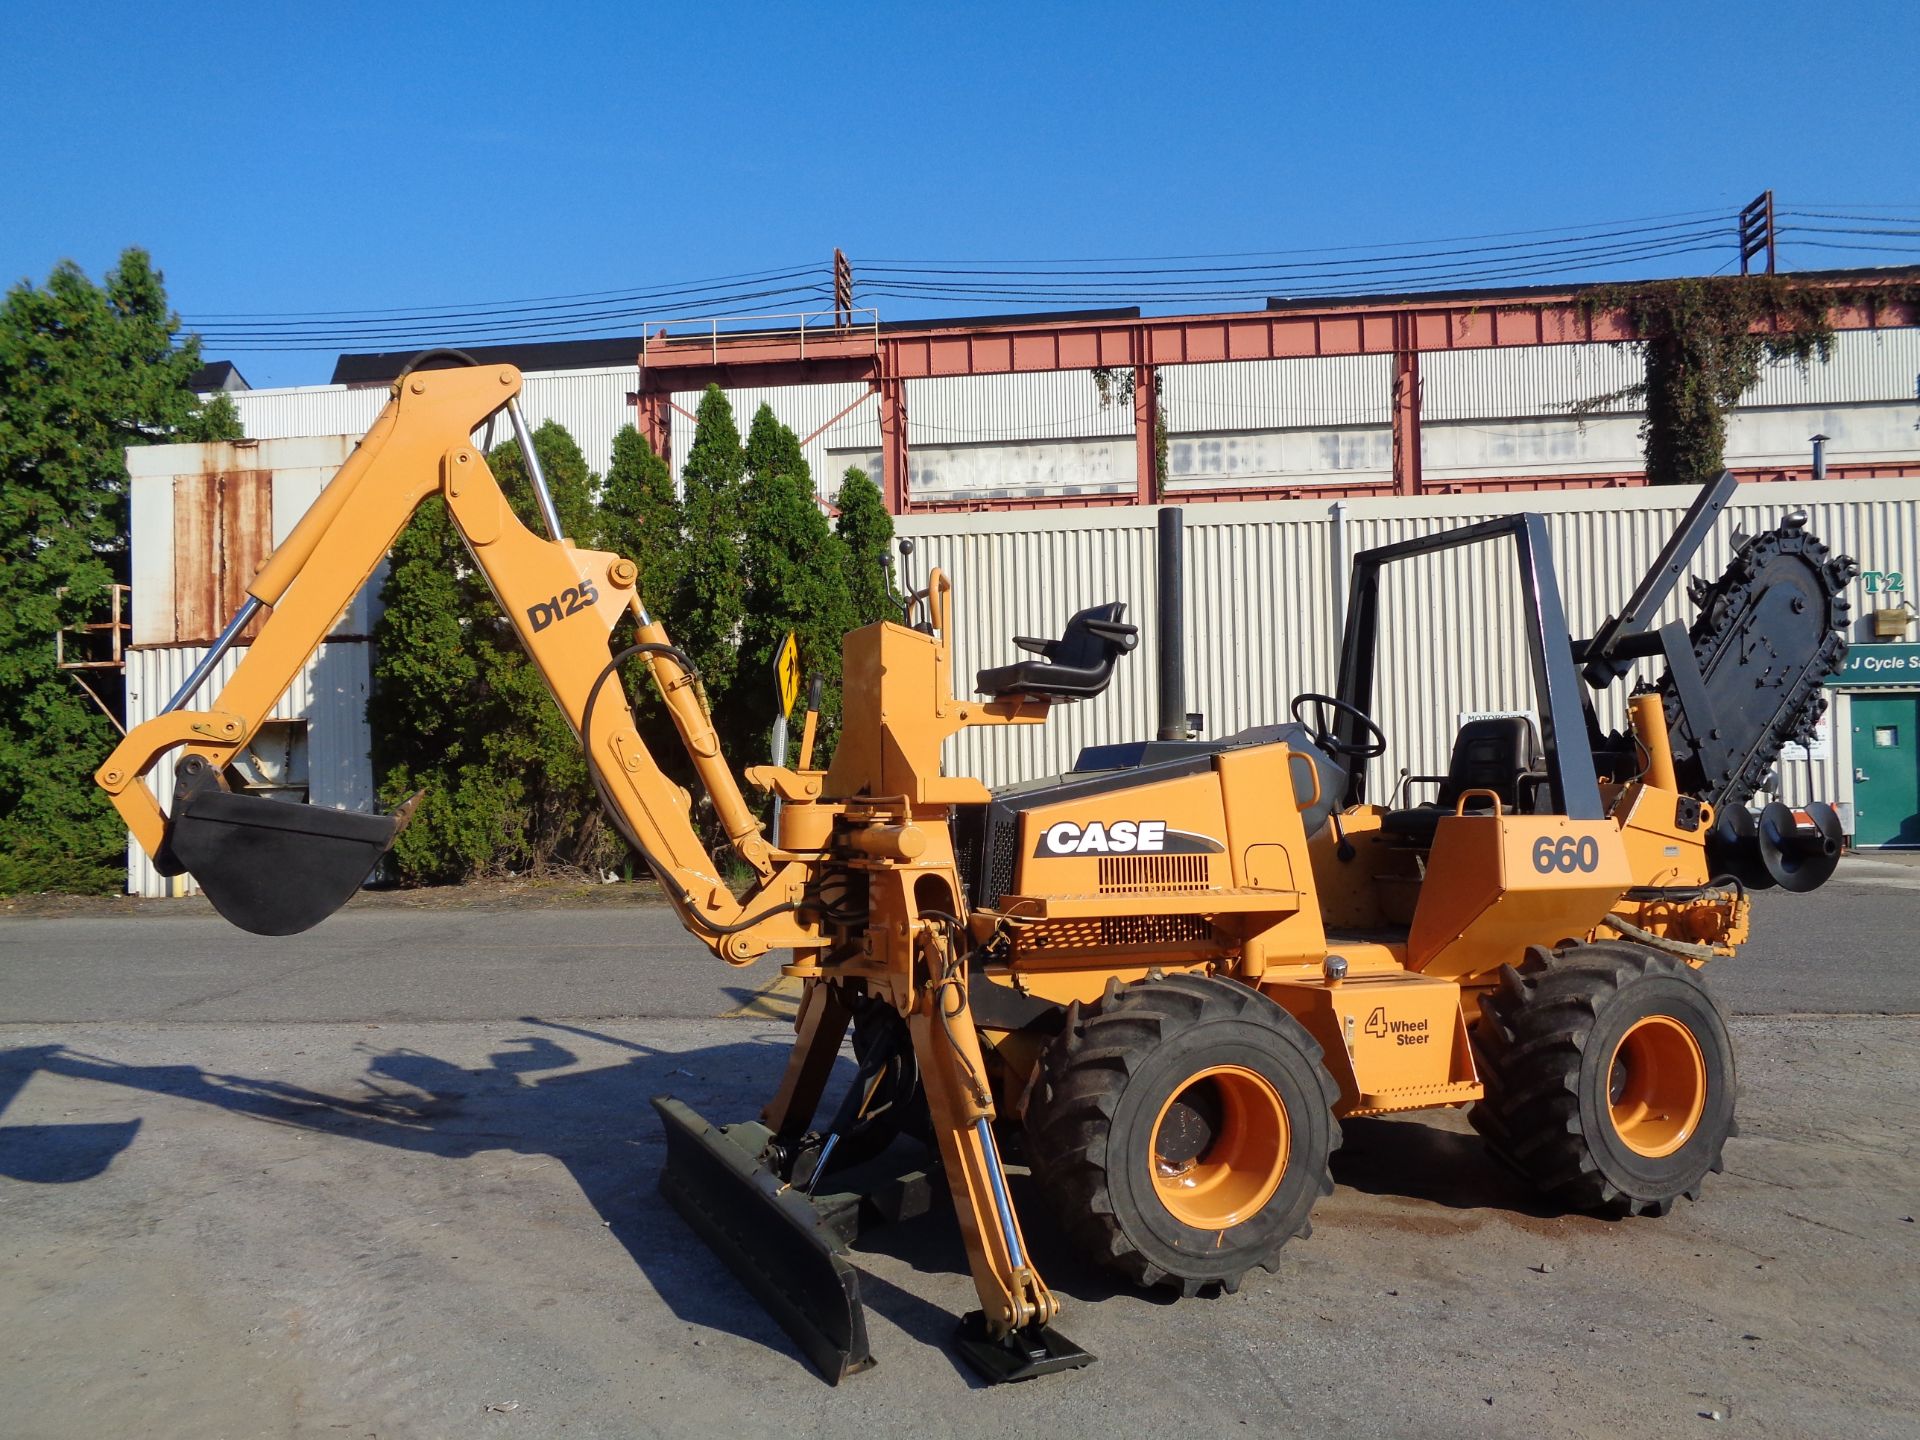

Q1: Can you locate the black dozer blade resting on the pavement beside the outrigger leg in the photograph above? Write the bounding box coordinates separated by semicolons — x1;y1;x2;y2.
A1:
653;1094;874;1384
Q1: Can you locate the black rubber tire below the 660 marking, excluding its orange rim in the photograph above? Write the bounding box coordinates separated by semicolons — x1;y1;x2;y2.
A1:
1471;943;1738;1215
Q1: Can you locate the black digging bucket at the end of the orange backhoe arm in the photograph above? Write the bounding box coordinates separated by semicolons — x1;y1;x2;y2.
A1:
165;783;401;935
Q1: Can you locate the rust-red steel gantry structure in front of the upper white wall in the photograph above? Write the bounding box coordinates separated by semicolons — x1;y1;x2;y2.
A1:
634;271;1920;515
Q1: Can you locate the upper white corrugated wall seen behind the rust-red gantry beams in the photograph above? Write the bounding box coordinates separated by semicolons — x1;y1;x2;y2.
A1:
232;328;1920;499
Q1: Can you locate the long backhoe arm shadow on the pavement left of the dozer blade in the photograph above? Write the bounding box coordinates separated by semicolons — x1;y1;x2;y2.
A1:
0;1018;898;1373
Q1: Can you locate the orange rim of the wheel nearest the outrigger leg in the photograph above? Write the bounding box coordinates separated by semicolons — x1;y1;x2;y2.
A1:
1148;1066;1292;1231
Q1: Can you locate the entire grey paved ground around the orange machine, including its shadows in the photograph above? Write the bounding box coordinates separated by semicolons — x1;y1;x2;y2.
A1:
0;860;1920;1440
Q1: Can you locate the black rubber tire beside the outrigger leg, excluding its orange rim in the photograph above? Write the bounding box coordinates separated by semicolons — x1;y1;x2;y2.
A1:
1025;975;1340;1294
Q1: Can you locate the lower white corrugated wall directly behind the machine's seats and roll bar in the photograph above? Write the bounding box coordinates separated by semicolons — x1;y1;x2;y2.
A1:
899;480;1920;821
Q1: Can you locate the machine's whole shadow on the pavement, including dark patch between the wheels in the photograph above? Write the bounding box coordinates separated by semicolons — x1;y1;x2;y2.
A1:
0;1016;1557;1384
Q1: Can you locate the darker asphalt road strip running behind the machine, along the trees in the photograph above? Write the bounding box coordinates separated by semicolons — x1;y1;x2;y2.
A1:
11;858;1920;1023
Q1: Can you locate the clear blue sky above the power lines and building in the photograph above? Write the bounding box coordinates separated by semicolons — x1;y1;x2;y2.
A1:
0;0;1920;384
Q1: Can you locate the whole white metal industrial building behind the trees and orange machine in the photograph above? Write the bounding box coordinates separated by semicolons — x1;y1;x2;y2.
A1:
127;288;1920;893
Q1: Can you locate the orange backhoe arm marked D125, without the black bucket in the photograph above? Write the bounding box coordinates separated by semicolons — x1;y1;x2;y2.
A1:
94;365;820;964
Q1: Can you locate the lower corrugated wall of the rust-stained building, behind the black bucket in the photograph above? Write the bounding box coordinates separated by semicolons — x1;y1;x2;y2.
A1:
127;639;374;895
